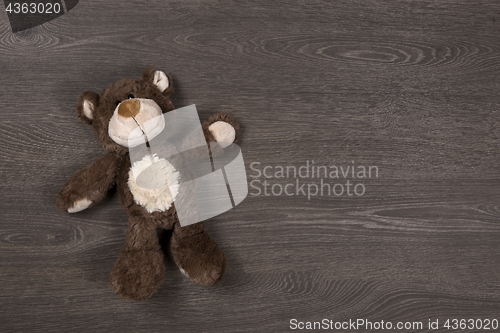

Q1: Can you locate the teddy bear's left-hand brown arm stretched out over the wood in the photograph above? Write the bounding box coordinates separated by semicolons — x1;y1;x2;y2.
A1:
57;153;118;213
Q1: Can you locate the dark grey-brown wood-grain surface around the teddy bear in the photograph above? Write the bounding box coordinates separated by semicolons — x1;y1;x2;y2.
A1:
0;0;500;332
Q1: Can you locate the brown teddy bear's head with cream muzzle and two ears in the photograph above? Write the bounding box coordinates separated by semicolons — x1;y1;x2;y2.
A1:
77;67;174;154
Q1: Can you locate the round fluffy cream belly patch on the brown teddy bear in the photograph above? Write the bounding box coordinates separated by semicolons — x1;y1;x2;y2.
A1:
128;155;180;213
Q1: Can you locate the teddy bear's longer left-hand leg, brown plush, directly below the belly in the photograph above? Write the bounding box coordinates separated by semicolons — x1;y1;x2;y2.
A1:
109;216;165;301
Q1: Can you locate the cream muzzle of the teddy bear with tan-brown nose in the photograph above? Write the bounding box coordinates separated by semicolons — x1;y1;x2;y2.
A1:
108;98;165;147
